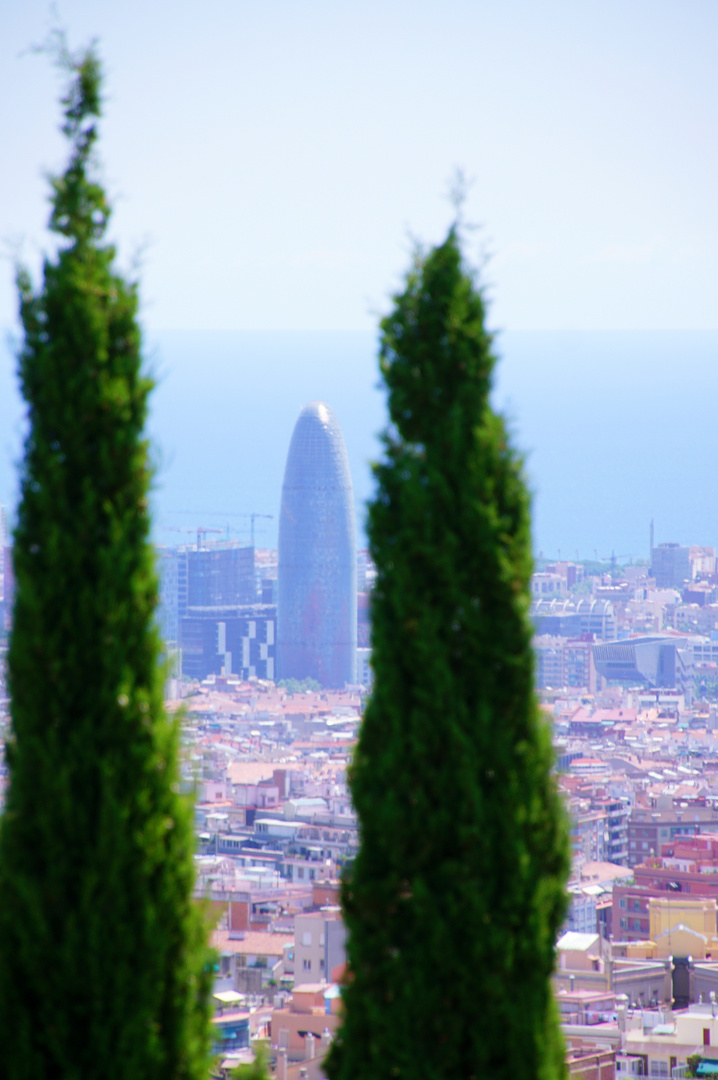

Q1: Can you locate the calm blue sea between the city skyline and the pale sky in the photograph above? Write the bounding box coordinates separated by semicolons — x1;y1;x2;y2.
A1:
0;330;718;563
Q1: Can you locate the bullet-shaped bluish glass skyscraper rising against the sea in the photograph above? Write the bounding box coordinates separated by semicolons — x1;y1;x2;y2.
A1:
276;402;356;689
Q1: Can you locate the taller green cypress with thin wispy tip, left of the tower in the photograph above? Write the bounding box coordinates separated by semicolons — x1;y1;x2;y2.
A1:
0;50;211;1080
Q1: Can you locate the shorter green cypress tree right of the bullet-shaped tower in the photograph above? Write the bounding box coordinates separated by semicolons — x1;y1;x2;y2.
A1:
327;227;568;1080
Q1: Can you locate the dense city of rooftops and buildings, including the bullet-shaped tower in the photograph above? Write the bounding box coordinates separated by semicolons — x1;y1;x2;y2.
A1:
1;402;718;1080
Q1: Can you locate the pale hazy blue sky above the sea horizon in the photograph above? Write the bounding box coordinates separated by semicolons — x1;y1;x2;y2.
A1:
0;0;718;330
